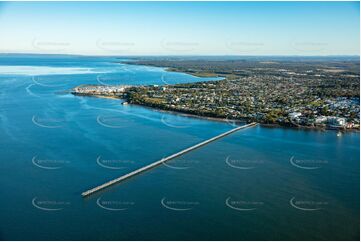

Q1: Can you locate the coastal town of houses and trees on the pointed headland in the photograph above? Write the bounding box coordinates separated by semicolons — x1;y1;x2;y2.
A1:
73;58;360;130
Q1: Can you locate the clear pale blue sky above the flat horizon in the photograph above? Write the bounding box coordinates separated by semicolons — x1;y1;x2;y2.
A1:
0;2;360;56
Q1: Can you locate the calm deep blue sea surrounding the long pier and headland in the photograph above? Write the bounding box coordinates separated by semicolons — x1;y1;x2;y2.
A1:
0;55;360;240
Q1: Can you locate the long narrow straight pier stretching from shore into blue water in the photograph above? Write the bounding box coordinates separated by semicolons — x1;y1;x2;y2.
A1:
81;123;257;197
